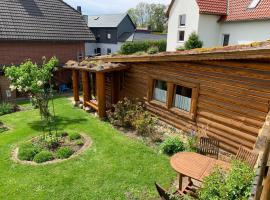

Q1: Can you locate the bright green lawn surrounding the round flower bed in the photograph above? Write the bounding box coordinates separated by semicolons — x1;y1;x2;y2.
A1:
0;98;176;200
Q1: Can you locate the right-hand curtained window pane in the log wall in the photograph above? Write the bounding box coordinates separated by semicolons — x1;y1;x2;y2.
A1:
173;85;192;112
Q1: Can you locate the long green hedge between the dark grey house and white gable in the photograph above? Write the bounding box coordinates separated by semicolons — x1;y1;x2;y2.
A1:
120;40;167;55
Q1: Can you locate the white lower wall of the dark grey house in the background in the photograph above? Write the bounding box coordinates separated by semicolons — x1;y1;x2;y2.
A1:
85;43;122;56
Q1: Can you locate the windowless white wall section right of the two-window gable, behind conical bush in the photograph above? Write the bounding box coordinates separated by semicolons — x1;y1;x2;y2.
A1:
198;14;220;47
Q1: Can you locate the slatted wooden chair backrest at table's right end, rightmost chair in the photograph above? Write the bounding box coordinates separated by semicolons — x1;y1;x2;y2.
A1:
235;146;259;168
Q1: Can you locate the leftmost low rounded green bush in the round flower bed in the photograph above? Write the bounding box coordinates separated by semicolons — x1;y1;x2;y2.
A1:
18;143;40;161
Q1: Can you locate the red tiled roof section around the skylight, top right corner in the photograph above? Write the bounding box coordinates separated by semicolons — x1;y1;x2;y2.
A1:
225;0;270;21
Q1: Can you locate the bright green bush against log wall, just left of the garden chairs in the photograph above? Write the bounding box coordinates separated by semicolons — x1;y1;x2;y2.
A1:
160;137;185;155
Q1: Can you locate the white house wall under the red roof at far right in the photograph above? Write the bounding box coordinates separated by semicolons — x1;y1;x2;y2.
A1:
219;20;270;45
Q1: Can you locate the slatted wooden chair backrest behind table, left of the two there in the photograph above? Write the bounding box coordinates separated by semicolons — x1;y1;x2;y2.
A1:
199;137;219;159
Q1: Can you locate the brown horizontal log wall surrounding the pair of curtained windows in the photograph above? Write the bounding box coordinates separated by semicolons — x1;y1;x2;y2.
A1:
119;61;270;153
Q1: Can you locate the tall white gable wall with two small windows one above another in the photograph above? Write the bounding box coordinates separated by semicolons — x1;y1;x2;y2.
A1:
167;0;199;51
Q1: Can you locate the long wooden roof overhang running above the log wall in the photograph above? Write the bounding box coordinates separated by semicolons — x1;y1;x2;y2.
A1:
87;42;270;63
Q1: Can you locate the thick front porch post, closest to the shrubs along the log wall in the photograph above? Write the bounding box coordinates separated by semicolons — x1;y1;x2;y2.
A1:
96;72;106;119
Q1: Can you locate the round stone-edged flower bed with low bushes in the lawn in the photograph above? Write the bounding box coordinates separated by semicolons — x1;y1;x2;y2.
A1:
12;133;91;165
